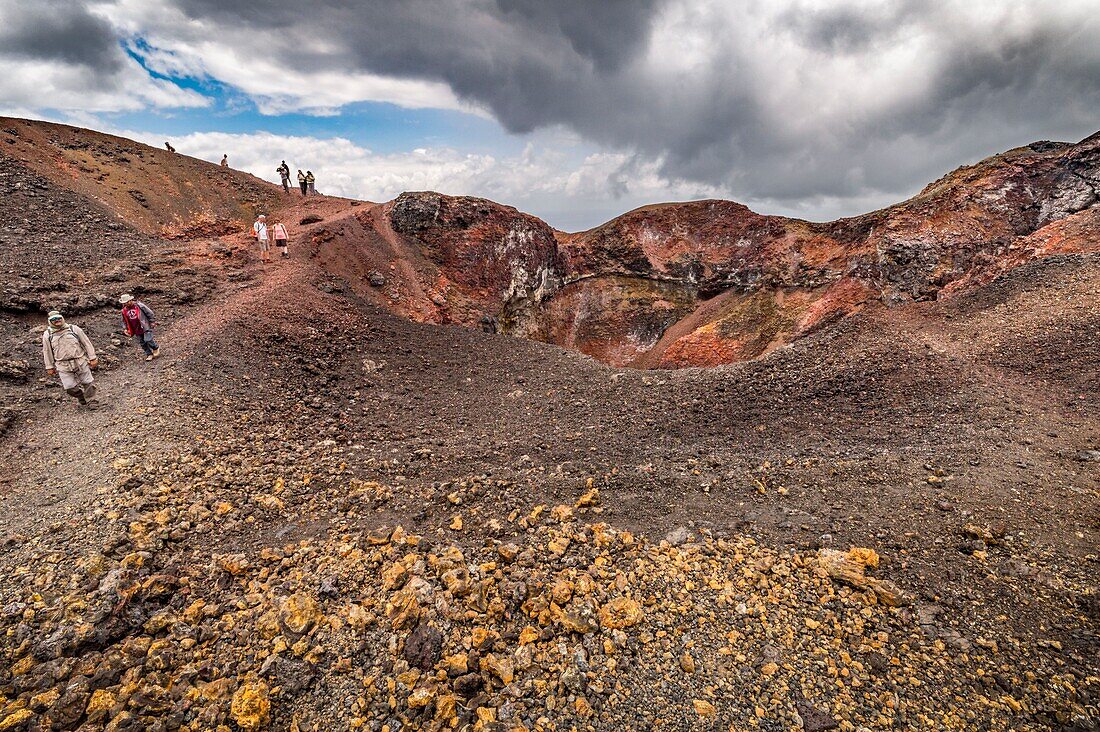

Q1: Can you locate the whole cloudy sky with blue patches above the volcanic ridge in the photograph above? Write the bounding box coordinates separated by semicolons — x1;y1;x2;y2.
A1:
0;0;1100;230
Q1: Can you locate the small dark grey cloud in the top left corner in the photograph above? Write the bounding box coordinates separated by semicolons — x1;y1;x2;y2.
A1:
0;0;123;70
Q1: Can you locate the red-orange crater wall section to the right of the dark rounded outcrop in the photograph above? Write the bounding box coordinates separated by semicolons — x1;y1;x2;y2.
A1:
540;134;1100;368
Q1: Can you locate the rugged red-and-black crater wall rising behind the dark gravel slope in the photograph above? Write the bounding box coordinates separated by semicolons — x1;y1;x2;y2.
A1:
288;127;1100;368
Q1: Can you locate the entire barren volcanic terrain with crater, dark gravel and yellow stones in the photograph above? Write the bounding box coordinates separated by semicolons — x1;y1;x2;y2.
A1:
0;120;1100;731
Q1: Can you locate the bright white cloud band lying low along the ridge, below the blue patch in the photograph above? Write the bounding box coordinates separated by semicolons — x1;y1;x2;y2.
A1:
114;130;748;229
